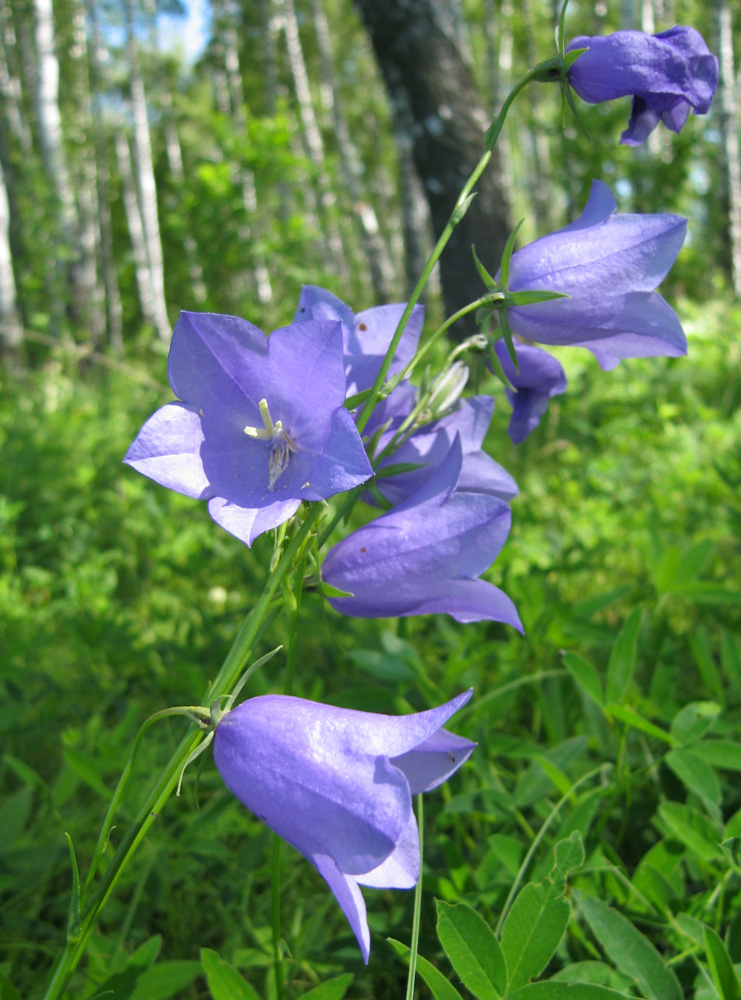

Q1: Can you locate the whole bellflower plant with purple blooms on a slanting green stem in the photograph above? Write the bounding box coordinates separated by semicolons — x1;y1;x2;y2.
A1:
39;6;717;1000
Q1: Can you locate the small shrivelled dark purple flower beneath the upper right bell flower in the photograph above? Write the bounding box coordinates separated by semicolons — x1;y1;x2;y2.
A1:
494;340;568;444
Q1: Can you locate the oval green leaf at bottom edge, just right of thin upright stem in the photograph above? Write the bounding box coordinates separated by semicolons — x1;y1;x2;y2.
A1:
436;899;507;1000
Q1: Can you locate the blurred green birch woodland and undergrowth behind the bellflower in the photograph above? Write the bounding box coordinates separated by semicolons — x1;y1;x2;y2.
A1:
0;0;741;1000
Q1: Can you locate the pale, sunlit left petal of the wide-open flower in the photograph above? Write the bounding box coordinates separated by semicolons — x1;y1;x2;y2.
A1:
124;403;213;500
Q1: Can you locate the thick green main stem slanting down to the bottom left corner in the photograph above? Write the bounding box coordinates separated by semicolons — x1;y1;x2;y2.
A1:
44;504;323;1000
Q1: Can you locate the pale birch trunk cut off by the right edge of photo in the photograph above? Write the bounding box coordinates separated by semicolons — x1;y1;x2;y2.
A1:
713;0;741;298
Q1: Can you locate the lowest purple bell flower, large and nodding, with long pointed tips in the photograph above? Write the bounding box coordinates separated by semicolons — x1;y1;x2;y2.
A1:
214;691;476;963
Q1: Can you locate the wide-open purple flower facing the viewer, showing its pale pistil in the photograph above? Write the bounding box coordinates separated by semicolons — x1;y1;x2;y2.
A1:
124;312;372;545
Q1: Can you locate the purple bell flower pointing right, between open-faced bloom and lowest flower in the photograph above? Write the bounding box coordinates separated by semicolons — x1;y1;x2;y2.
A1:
322;436;522;631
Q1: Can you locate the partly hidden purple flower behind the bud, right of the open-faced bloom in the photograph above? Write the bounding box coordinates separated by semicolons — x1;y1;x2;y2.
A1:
376;396;519;506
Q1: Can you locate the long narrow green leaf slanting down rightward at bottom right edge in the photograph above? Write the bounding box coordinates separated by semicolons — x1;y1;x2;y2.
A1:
577;893;683;1000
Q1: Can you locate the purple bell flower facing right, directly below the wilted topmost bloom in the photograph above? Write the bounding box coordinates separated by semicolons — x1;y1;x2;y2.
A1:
507;181;687;369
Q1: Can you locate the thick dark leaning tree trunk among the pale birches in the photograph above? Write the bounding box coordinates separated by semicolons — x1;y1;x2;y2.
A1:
356;0;509;335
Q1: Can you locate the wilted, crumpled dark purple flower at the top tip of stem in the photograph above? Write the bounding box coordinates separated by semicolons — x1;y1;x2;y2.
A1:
567;25;718;146
